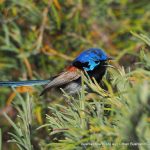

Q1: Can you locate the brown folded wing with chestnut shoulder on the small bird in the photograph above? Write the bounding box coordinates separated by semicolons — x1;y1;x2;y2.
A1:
41;69;81;95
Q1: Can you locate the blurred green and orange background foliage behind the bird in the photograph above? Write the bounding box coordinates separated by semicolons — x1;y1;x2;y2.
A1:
0;0;150;150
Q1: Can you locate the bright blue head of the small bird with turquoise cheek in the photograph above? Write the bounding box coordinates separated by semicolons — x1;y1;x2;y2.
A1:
72;48;109;71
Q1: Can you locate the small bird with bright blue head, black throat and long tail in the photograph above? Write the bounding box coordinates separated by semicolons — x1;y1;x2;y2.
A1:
0;48;112;95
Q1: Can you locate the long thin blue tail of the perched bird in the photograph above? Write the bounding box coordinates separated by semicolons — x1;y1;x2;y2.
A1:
0;80;50;87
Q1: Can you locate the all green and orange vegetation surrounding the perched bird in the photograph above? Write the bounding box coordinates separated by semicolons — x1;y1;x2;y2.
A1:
0;0;150;150
